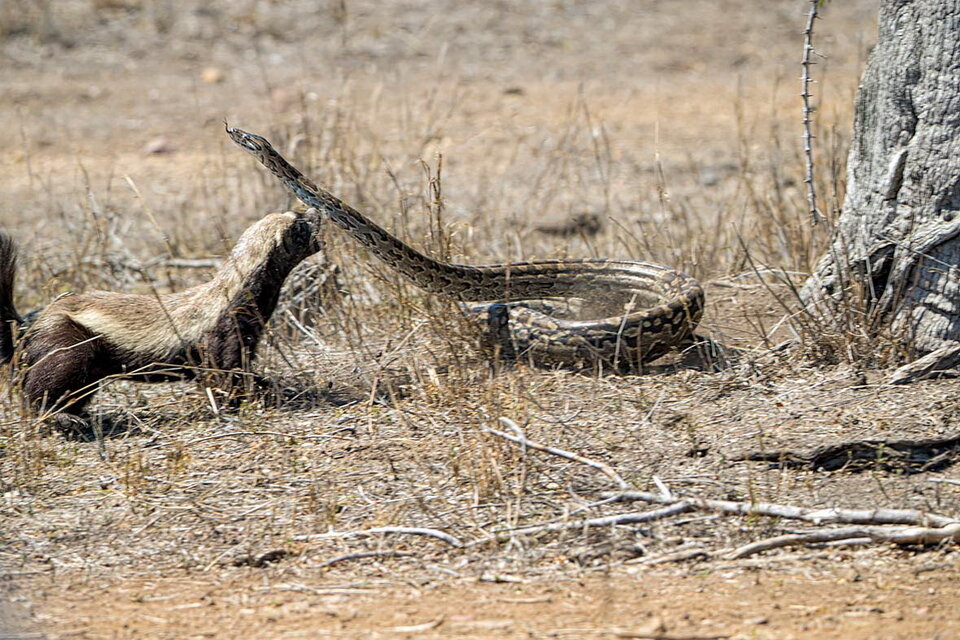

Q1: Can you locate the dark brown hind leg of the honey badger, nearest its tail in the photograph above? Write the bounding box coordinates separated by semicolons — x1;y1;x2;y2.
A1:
23;316;103;432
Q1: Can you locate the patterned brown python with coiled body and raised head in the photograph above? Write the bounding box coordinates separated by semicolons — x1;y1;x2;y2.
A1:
226;126;704;370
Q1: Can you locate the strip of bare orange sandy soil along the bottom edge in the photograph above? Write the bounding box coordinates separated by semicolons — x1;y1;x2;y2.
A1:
7;553;960;640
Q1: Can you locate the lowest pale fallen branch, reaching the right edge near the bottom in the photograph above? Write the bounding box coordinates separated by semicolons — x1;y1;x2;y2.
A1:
727;522;960;560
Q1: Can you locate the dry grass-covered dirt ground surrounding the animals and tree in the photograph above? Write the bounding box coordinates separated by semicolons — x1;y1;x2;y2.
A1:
0;0;960;638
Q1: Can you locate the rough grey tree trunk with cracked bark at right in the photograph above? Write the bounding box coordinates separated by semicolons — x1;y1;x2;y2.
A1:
803;0;960;355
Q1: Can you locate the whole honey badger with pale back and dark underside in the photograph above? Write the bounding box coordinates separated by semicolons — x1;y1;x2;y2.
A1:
0;209;320;425
